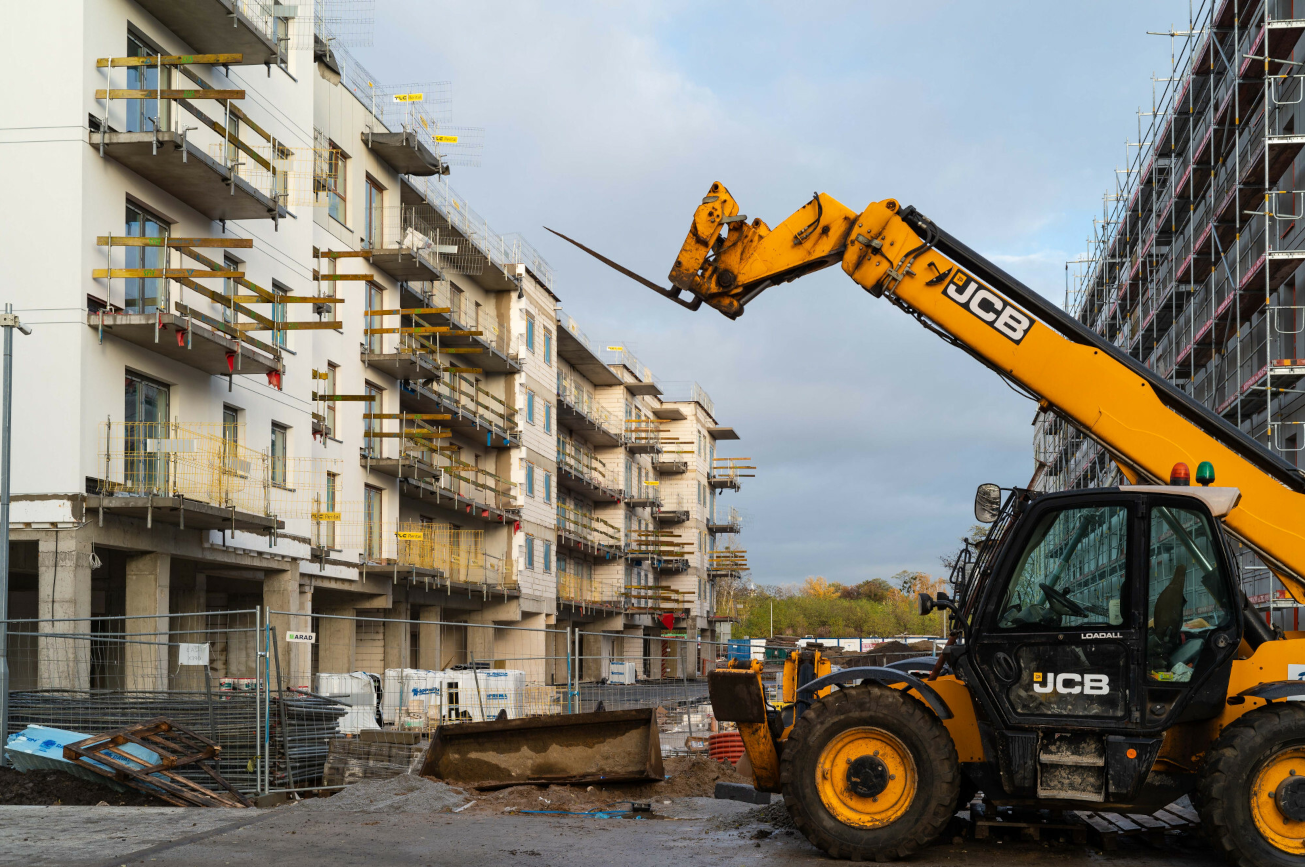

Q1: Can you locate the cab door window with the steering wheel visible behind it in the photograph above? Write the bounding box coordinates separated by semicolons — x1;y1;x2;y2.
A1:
997;505;1129;629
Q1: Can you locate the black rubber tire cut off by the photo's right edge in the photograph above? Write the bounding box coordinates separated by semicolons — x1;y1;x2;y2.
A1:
1195;702;1305;867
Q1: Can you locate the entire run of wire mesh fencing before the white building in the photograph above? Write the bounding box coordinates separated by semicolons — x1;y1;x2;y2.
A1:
4;608;728;794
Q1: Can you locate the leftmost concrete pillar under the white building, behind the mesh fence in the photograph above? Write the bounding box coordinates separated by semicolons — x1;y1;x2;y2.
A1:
37;530;94;689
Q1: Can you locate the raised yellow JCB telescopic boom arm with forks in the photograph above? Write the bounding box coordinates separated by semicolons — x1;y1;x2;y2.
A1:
550;183;1305;605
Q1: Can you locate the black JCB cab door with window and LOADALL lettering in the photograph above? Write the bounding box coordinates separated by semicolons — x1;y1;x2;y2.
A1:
972;494;1143;731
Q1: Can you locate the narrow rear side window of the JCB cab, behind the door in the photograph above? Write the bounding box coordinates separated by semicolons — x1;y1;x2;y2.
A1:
1147;505;1233;683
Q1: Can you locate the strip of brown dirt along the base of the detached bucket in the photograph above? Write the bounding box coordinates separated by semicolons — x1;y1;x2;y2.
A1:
467;756;752;813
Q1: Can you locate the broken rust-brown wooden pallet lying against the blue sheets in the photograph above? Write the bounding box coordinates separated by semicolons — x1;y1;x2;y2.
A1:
63;717;253;807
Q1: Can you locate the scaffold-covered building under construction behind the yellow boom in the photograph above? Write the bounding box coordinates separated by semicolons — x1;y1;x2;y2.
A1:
1034;0;1305;629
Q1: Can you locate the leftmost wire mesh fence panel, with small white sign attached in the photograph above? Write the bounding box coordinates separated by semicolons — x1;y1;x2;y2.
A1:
4;610;262;793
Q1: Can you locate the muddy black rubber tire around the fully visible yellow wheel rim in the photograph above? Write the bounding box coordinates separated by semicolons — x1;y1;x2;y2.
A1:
779;686;960;860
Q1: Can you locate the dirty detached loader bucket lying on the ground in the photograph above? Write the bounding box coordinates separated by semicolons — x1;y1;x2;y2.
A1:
422;708;666;789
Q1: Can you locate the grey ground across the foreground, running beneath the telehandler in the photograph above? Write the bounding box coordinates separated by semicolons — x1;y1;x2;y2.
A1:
0;798;1227;867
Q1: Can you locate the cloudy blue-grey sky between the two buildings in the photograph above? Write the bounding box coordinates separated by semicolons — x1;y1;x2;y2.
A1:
354;0;1188;584
